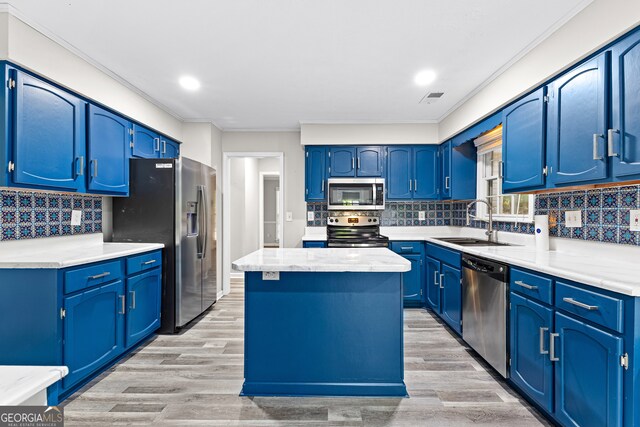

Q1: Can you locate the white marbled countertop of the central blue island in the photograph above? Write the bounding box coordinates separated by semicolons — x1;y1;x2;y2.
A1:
232;248;411;272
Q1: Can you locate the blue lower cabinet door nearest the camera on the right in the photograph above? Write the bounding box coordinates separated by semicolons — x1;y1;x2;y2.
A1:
555;312;623;427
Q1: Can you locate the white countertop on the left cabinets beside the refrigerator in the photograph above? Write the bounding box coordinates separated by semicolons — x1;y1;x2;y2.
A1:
0;233;164;268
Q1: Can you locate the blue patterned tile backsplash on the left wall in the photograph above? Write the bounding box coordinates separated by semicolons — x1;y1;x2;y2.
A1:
0;190;102;240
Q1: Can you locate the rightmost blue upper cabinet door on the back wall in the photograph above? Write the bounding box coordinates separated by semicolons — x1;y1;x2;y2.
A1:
413;145;440;200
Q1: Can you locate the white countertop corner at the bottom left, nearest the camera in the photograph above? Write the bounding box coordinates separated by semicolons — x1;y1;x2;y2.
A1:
0;366;69;406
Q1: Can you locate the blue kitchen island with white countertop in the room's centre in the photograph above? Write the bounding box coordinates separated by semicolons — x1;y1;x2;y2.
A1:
233;248;411;397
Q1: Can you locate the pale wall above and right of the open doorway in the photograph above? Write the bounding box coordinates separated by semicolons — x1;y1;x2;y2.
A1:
222;132;306;248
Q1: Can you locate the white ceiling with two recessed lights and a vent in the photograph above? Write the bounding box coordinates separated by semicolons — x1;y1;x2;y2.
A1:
10;0;590;129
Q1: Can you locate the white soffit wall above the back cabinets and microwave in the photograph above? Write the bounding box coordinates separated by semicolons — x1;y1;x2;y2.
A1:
300;123;438;145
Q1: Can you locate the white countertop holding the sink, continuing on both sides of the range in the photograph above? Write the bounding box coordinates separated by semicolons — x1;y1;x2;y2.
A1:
303;227;640;296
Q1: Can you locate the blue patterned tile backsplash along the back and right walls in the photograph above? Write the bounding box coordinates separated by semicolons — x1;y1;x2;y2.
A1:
307;185;640;245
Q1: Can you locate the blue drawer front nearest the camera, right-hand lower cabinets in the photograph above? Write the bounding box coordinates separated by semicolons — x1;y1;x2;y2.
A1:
556;281;624;333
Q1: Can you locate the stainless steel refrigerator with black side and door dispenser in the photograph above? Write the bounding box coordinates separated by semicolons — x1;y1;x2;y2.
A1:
113;158;217;333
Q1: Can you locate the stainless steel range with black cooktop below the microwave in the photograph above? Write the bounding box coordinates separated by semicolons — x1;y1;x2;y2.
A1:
327;215;389;248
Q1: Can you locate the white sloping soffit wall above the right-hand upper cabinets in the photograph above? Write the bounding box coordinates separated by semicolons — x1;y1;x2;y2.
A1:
438;0;640;141
